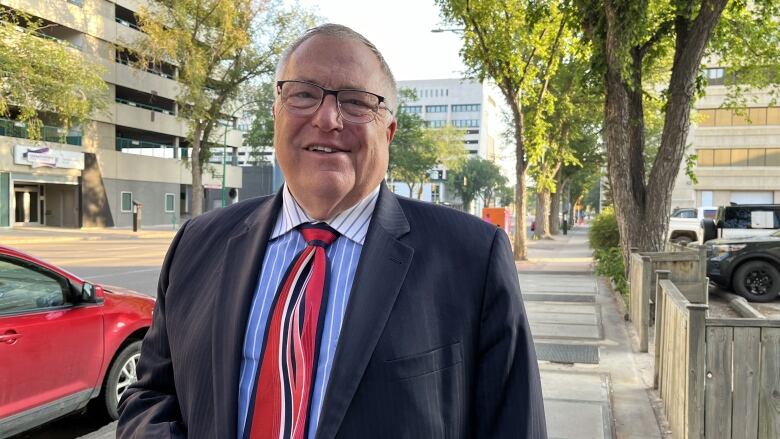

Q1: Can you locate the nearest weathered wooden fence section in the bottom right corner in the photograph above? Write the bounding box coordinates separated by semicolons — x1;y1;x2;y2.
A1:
655;272;780;439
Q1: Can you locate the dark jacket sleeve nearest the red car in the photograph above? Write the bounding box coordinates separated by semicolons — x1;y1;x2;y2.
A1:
116;223;188;439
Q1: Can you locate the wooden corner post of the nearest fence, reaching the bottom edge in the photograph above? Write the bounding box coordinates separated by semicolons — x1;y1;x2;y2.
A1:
685;303;708;438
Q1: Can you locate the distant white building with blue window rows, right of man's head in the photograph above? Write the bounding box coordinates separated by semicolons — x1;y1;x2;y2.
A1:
391;78;513;212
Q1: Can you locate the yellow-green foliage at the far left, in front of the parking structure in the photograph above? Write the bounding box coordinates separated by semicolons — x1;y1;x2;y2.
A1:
0;11;108;139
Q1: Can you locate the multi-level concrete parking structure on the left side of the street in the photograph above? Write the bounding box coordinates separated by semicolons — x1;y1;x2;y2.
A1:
0;0;243;227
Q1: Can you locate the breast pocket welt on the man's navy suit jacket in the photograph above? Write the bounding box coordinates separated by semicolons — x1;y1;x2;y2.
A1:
376;342;463;381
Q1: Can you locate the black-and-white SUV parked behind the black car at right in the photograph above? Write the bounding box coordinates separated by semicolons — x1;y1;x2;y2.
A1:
701;204;780;242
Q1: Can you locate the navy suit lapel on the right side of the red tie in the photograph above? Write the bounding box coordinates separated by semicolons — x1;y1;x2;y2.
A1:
316;183;414;439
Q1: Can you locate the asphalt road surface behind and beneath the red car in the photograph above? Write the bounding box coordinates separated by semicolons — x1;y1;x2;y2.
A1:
6;234;173;439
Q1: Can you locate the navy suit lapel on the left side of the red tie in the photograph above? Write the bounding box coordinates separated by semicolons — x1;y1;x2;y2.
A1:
213;193;282;438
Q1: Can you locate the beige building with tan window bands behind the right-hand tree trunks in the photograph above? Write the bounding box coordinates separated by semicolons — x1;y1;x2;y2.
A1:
672;67;780;208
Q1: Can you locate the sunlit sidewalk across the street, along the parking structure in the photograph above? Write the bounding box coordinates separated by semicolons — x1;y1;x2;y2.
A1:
0;225;176;246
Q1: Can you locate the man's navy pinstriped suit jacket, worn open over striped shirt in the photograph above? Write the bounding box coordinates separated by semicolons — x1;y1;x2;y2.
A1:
117;184;547;439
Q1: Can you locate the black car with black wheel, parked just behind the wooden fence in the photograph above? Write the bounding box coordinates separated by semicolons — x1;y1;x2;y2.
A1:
706;231;780;302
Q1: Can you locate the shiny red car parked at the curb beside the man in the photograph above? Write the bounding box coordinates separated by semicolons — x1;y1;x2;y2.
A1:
0;246;154;439
